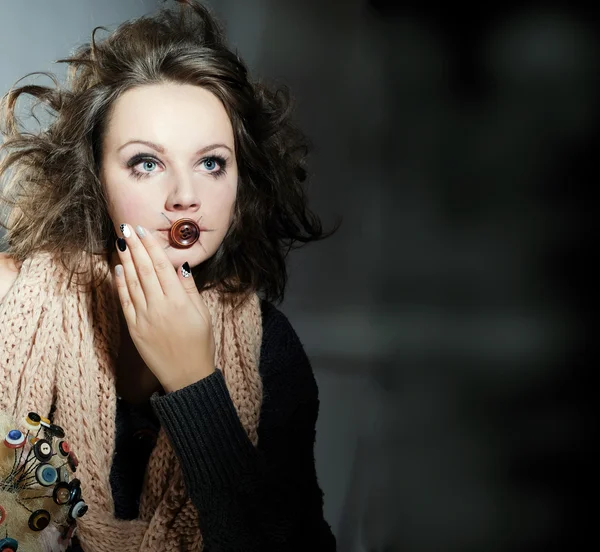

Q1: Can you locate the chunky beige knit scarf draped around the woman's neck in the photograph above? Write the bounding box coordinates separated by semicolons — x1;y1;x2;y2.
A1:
0;254;262;552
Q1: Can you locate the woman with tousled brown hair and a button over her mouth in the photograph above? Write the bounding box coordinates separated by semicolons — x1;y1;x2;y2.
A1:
0;0;335;552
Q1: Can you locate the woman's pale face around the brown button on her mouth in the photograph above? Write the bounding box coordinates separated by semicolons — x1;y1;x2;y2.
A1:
100;84;238;267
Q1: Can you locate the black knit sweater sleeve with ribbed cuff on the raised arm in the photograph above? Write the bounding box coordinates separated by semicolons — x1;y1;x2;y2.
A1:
152;306;336;552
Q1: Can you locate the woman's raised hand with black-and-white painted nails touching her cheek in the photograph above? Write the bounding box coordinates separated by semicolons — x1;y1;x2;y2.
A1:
115;225;215;392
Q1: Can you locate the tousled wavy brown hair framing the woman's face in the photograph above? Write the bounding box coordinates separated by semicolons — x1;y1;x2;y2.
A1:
0;0;331;300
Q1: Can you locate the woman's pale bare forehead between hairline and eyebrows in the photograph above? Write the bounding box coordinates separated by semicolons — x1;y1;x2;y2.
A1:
104;83;233;149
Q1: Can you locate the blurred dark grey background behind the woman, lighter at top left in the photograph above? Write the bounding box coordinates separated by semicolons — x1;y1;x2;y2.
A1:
0;0;599;552
